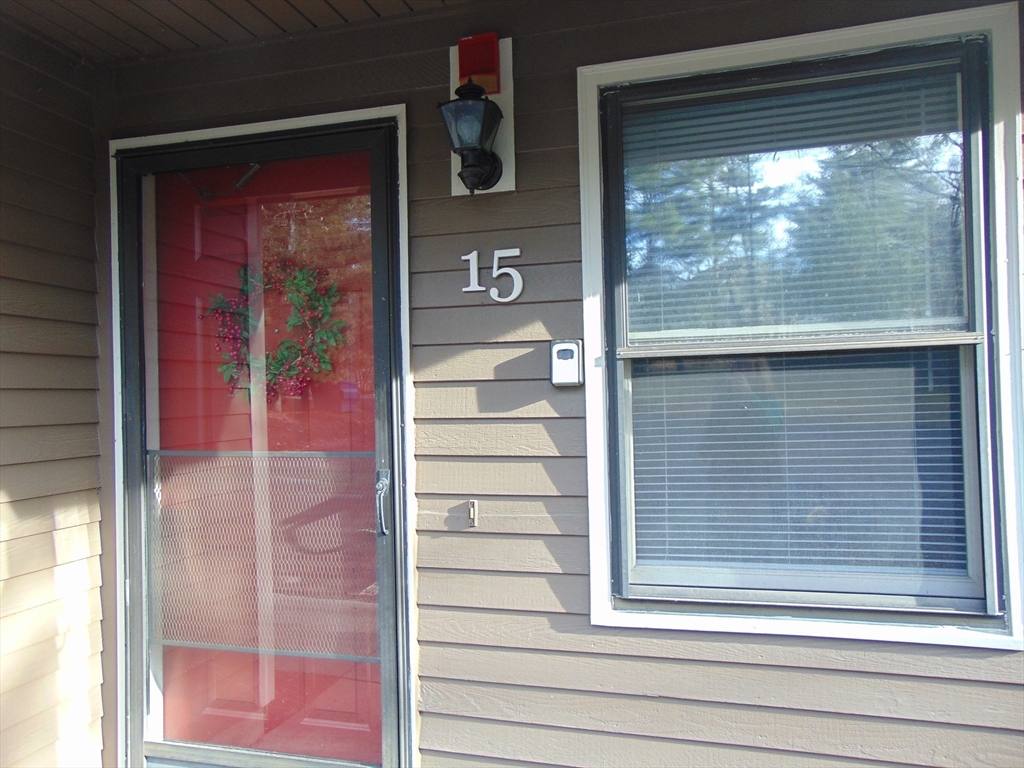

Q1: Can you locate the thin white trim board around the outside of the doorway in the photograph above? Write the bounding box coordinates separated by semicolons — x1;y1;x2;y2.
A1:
109;104;420;766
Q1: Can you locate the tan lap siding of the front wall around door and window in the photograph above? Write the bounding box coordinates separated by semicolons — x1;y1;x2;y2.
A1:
92;0;1024;768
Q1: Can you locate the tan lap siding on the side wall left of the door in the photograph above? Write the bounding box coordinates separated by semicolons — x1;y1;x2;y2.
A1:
0;25;102;768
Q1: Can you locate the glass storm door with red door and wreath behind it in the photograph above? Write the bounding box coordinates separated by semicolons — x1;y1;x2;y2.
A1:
122;123;400;765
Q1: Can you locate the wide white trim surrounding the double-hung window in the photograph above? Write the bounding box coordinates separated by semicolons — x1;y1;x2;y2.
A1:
577;3;1024;650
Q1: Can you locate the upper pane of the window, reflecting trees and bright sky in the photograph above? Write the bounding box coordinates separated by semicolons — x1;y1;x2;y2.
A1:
622;68;969;344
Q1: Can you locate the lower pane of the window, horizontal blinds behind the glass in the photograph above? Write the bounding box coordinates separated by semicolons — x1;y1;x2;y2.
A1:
630;348;969;594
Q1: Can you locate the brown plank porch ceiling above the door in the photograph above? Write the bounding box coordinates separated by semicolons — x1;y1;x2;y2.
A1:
0;0;468;63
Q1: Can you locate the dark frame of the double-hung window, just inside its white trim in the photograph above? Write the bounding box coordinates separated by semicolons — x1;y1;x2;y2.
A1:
599;36;1005;622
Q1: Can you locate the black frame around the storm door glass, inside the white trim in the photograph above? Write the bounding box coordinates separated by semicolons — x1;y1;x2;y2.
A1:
113;117;413;766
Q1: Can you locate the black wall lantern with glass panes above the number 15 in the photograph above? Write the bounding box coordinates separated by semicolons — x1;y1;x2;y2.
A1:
437;78;503;195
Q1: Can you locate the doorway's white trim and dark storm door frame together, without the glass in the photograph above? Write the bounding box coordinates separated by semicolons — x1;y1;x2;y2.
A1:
110;105;415;768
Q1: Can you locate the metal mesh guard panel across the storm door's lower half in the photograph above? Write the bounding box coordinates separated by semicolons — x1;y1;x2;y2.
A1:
148;453;378;659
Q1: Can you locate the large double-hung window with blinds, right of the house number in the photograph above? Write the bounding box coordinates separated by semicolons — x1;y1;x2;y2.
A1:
581;6;1019;647
